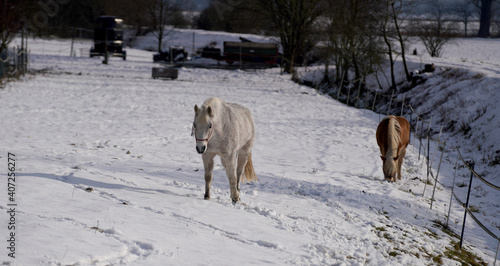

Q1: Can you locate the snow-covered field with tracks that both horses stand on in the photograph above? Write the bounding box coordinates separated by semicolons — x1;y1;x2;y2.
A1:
0;32;500;265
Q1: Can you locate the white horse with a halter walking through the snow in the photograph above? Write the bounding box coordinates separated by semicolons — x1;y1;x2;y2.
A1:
192;97;257;203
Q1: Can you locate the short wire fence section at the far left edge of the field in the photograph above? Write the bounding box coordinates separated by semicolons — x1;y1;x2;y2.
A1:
0;47;29;80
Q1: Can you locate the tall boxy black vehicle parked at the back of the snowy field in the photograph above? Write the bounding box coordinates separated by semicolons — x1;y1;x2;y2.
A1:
90;16;127;60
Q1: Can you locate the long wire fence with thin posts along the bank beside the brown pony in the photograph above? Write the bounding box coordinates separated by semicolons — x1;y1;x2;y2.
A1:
324;82;500;265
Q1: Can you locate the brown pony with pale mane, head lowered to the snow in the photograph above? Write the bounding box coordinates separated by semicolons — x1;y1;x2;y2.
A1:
377;115;410;182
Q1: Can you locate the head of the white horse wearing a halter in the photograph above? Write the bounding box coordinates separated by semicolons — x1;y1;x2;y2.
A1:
192;105;214;154
